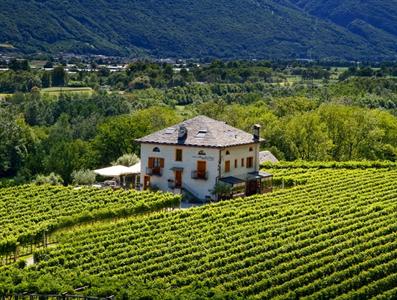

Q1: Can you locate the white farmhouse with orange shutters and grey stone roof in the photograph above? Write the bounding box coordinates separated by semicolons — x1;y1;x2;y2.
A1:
137;116;271;200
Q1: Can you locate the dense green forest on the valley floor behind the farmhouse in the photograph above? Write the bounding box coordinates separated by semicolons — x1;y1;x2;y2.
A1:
0;61;397;184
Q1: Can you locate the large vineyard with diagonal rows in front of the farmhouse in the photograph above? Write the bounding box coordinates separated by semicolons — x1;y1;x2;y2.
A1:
0;165;397;299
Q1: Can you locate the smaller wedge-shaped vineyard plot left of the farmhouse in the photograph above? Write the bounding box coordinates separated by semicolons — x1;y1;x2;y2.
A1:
0;185;180;258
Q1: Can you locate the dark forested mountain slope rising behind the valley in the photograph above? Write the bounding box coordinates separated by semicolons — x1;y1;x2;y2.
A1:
0;0;397;60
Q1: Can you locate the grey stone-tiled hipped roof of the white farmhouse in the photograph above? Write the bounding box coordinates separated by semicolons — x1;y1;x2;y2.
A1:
137;116;258;148
